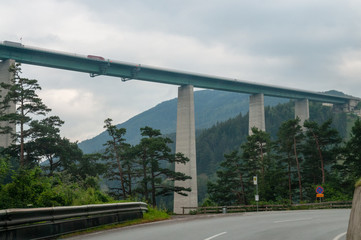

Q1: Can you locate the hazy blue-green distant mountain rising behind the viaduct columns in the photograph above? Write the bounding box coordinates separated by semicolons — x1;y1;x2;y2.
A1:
79;90;288;153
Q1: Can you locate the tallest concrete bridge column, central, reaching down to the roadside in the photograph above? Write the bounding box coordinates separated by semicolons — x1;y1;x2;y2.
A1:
173;85;198;214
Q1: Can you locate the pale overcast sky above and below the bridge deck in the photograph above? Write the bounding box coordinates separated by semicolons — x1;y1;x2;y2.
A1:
0;0;361;141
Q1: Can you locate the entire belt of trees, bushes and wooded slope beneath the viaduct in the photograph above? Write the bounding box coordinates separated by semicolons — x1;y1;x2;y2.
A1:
0;62;361;209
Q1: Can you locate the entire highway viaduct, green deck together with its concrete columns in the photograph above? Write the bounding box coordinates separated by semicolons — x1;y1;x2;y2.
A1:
0;41;361;213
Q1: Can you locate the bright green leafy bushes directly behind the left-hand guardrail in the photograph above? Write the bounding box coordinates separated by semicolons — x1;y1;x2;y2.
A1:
0;168;114;209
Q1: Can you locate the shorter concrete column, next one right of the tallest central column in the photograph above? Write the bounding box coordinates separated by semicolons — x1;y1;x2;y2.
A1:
248;93;266;135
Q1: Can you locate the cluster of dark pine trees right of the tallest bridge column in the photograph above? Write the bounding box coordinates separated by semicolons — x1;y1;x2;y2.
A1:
204;118;361;205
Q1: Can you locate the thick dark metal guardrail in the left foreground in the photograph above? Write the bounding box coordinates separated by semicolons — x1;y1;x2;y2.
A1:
0;202;148;240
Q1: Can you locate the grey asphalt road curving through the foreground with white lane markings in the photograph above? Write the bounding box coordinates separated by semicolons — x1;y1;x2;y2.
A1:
64;209;350;240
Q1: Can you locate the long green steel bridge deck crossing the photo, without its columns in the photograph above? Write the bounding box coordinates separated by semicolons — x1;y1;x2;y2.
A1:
0;41;361;104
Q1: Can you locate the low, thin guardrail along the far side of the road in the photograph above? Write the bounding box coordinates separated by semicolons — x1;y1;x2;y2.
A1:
183;201;352;214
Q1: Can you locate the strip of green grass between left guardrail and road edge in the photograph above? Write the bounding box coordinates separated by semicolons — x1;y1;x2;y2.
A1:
58;206;170;239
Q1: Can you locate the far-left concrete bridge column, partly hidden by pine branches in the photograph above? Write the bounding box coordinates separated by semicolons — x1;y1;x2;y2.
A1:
0;59;16;148
